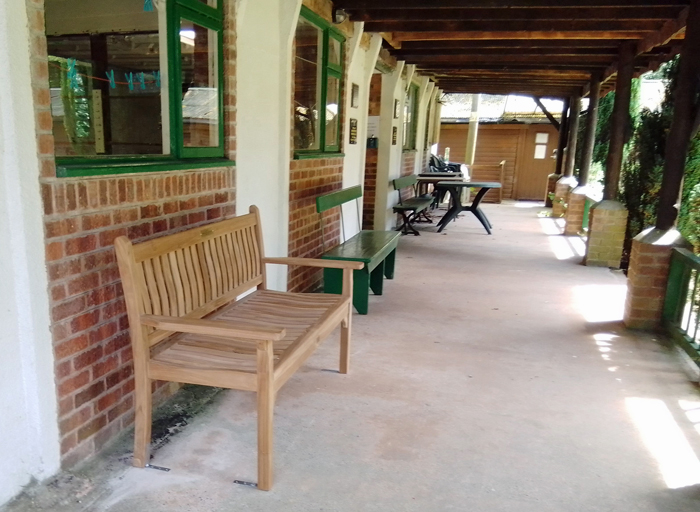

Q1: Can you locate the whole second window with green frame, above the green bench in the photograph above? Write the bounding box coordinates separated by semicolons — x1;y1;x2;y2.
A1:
294;7;344;154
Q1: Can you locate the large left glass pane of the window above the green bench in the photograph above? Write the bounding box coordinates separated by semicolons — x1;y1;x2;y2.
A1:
294;19;323;149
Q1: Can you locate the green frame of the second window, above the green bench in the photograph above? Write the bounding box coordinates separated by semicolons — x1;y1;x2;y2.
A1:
294;6;345;158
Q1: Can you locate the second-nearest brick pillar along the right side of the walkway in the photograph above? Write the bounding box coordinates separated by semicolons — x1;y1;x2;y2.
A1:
584;200;627;268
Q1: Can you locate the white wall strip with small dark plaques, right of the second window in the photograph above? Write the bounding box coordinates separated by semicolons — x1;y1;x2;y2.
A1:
342;29;382;238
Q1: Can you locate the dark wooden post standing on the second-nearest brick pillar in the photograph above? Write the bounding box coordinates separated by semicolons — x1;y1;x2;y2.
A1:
603;41;636;200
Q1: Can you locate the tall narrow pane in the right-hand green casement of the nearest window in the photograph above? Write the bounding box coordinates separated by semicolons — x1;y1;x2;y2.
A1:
180;20;220;148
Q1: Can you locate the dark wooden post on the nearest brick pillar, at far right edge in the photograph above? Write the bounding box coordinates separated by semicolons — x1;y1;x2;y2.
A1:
656;0;700;230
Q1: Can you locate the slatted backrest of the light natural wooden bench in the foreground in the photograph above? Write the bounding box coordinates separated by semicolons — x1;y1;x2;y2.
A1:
115;208;264;345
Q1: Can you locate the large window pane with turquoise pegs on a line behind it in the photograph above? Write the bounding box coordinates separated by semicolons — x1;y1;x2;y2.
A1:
46;0;170;157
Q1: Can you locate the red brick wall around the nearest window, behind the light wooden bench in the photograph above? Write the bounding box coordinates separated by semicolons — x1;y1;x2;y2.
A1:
27;0;236;466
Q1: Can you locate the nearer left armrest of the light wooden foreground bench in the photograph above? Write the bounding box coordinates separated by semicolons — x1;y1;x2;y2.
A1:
141;315;286;341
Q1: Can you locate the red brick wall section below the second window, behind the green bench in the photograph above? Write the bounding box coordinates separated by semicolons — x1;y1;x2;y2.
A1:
287;157;343;292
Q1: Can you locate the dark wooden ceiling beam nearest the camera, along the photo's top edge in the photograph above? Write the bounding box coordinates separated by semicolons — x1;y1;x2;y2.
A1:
333;0;689;10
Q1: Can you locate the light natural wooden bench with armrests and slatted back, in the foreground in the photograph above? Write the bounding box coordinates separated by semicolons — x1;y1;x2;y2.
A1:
115;206;363;490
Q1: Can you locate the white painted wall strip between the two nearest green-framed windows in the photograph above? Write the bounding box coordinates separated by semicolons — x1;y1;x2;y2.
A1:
236;0;301;290
